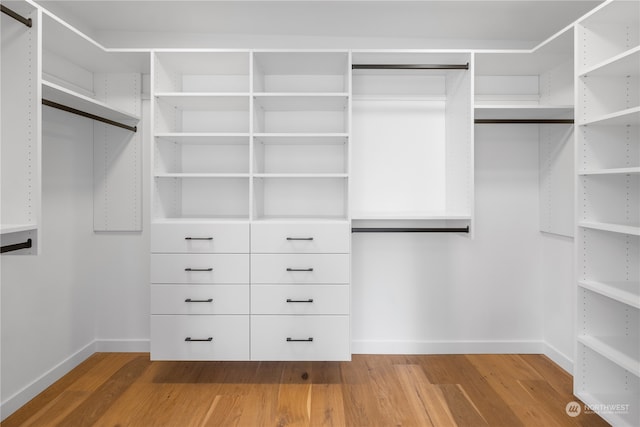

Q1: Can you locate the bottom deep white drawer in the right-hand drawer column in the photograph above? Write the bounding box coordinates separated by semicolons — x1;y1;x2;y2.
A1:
251;316;351;360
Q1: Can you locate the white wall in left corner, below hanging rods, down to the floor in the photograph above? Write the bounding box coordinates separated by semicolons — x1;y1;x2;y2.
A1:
0;106;149;418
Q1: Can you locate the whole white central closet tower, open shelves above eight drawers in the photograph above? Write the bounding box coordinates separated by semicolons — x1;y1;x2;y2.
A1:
151;50;350;360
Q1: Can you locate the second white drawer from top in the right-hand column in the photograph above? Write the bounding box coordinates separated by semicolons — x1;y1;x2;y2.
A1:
251;254;349;284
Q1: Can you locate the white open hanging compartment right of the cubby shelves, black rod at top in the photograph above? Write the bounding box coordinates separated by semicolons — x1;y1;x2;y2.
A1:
351;51;473;234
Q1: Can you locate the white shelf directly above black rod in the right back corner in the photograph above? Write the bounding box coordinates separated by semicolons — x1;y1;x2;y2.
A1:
474;104;573;120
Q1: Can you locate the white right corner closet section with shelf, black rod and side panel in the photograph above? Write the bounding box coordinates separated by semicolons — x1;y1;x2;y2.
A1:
474;27;575;236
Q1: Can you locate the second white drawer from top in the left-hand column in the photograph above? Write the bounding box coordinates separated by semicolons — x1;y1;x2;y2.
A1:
151;254;249;284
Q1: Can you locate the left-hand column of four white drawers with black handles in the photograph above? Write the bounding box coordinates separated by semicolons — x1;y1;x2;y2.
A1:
151;222;250;360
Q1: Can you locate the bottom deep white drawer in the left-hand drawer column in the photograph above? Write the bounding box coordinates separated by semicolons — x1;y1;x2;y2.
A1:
151;315;249;360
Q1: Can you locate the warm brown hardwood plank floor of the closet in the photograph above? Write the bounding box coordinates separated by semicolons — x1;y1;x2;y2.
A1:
2;353;608;427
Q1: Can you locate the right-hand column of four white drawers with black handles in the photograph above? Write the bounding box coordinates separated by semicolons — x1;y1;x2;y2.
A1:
251;222;351;360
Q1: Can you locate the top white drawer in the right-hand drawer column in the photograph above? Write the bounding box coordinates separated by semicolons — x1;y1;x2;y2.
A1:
251;223;351;253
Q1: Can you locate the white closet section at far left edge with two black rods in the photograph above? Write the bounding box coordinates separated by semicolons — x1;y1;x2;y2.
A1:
0;1;41;254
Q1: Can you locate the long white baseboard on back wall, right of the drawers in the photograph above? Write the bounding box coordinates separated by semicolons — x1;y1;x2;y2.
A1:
351;340;546;354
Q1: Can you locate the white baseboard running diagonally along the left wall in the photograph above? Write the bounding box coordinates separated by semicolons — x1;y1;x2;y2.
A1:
0;341;96;421
